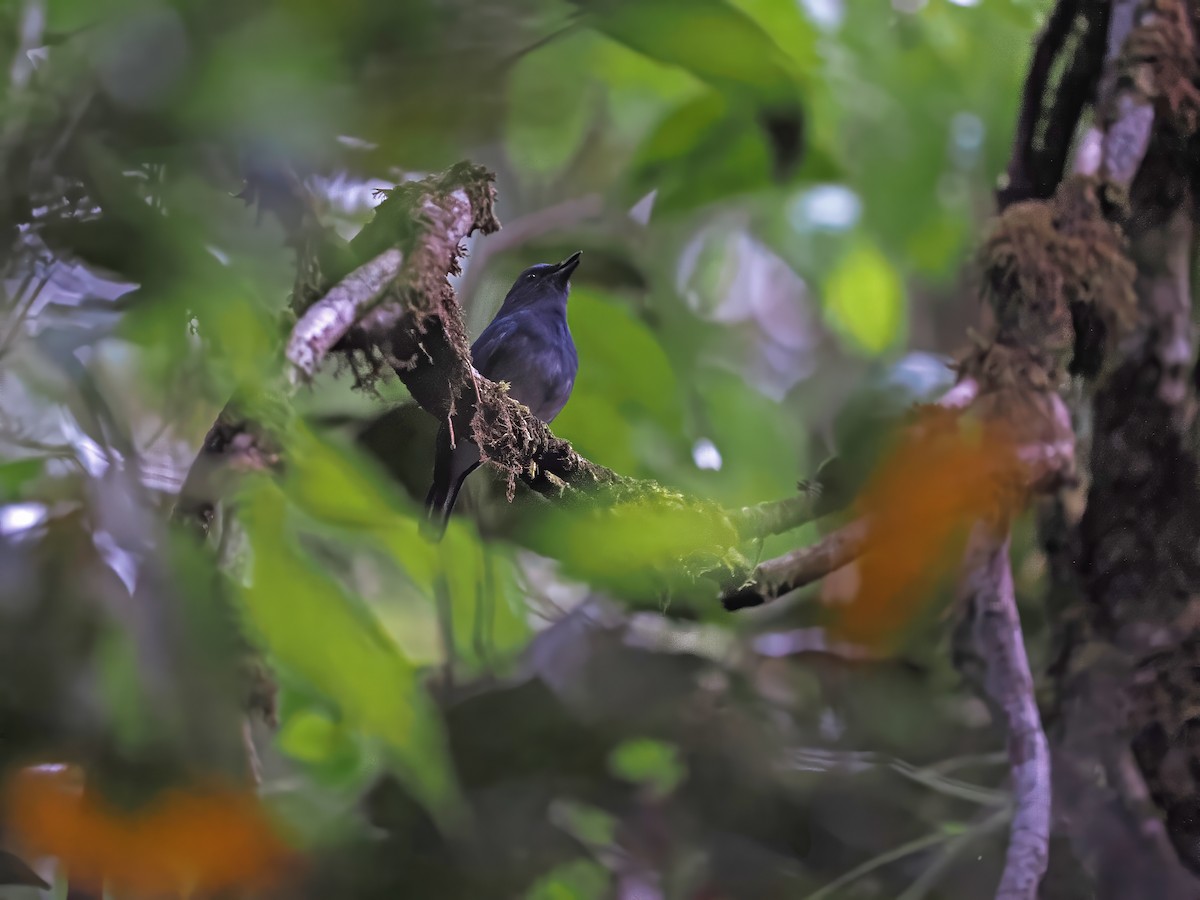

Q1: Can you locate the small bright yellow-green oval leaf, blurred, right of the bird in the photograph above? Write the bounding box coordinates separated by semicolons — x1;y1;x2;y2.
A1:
823;240;905;356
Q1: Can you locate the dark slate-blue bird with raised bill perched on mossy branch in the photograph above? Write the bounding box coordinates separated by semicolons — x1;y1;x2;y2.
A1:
425;252;583;540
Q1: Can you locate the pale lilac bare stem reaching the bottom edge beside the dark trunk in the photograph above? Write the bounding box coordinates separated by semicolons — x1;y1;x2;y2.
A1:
962;524;1050;900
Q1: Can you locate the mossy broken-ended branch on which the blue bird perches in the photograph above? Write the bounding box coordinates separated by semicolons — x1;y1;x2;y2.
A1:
176;163;835;577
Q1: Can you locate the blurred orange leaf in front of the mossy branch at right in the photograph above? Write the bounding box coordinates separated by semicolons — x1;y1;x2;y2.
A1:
827;407;1022;649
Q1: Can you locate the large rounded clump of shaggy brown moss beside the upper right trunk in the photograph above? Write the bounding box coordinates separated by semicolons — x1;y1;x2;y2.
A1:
980;176;1138;372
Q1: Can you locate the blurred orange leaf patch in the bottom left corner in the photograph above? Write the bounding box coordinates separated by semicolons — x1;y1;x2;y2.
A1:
5;767;289;895
